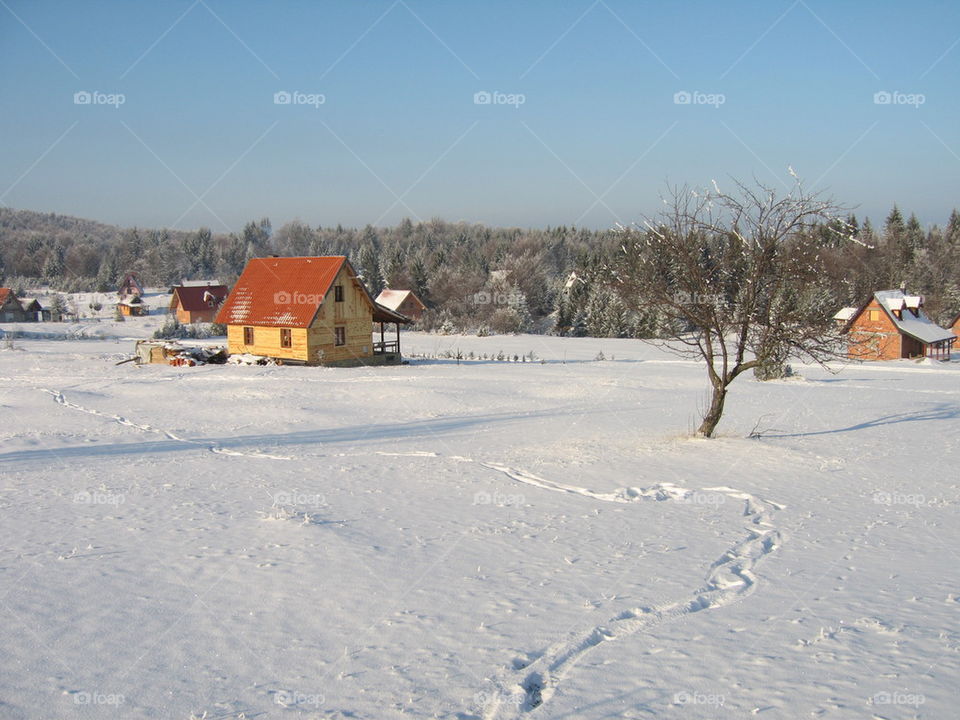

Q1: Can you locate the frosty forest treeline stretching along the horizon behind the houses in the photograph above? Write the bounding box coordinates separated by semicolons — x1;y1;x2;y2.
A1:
0;207;960;337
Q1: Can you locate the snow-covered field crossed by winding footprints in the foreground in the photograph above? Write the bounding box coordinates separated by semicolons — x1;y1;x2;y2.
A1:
0;324;960;720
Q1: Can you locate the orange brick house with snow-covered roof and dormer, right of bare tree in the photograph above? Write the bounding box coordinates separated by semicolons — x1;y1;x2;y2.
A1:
841;290;957;360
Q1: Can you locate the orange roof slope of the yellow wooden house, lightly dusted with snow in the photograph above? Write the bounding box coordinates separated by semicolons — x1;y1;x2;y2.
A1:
217;255;352;327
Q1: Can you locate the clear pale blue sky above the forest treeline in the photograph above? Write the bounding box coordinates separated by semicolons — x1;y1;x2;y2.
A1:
0;0;960;231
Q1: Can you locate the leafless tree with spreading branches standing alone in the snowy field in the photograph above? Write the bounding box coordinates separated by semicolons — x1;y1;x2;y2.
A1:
611;181;854;437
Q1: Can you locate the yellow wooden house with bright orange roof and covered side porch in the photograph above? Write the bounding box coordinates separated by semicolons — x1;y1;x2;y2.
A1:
216;256;410;365
